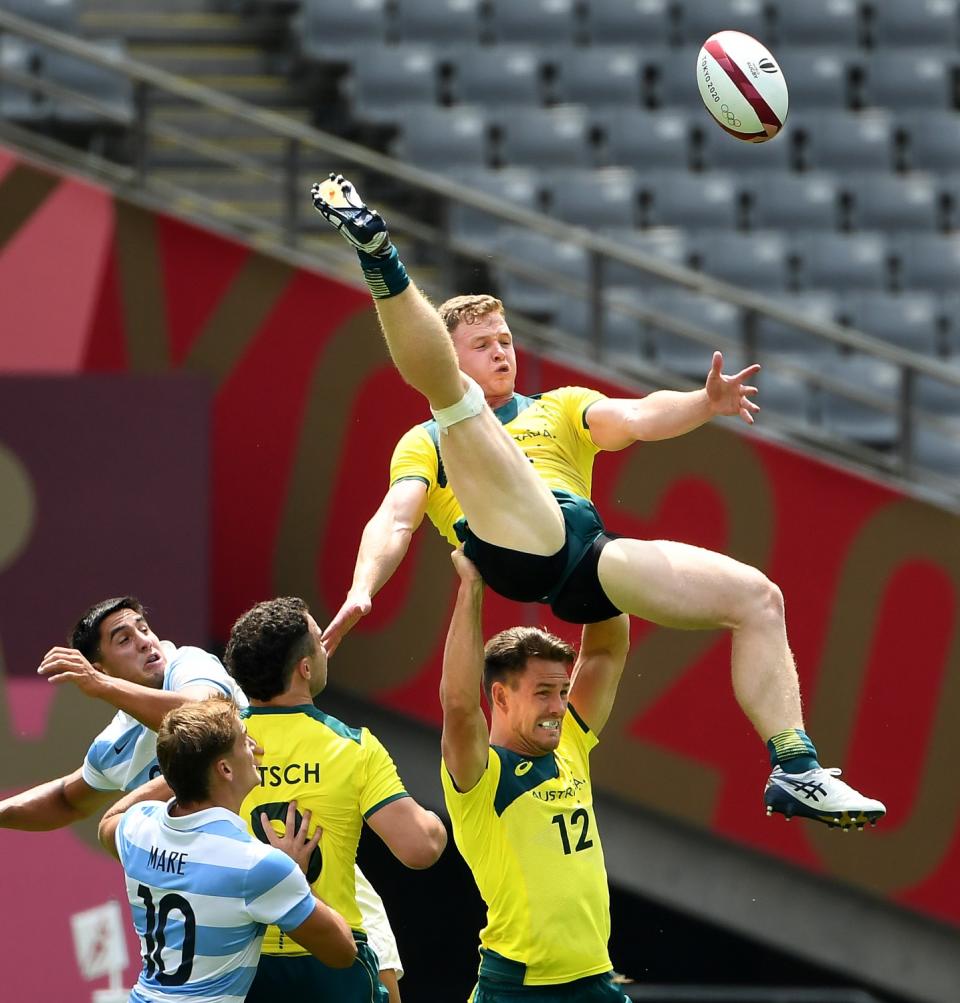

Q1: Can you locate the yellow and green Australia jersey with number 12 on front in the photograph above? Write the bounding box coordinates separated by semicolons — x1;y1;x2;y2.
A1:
440;706;612;986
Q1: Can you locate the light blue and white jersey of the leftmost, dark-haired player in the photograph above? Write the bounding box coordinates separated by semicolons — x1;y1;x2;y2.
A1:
83;641;247;790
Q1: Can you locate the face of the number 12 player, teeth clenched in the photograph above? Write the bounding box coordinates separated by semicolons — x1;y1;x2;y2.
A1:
504;658;570;755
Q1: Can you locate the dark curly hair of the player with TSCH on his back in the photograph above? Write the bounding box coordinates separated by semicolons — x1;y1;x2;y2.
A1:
224;596;315;700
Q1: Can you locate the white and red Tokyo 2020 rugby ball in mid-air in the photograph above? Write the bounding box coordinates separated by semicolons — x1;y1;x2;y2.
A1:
696;31;789;142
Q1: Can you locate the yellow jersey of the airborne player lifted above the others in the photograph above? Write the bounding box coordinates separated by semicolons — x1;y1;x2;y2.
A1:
390;386;604;547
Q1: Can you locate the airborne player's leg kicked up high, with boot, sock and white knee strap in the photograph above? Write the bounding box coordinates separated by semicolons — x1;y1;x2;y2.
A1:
314;176;565;557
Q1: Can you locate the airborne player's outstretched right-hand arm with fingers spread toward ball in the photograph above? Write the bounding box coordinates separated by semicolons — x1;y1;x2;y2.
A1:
587;352;760;450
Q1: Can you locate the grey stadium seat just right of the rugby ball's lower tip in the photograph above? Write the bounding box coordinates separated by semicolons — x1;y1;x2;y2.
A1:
791;111;894;171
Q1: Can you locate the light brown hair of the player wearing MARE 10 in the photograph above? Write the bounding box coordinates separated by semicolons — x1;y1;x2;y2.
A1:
156;696;240;804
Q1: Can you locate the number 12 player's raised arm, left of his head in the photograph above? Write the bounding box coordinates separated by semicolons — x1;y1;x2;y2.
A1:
440;551;490;791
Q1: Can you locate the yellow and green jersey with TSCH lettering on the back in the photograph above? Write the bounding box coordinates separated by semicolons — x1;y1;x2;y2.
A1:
240;704;409;956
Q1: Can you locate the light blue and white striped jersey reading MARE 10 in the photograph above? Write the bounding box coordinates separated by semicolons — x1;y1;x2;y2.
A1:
116;799;316;1003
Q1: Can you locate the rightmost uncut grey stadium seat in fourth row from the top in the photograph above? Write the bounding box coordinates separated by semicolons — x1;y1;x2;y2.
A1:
850;172;943;231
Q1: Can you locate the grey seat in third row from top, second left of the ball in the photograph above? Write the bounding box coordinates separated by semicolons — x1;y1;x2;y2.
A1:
498;104;594;168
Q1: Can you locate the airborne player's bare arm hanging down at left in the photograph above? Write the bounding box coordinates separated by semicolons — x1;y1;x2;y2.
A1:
323;478;426;655
